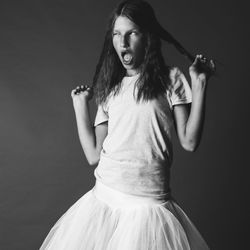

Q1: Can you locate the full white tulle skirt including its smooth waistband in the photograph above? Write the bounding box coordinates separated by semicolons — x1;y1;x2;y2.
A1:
40;181;209;250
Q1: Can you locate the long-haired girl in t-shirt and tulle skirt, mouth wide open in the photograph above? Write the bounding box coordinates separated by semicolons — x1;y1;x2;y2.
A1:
40;0;215;250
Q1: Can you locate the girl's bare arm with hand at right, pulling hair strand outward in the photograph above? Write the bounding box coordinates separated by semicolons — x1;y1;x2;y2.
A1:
174;56;214;152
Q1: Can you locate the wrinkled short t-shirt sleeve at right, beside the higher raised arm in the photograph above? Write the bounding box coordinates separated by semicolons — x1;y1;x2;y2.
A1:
170;67;192;106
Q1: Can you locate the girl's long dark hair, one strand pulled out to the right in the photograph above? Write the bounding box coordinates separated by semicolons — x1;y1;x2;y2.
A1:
93;0;194;104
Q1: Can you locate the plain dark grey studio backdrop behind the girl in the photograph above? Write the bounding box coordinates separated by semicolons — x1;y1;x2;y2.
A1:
0;0;250;250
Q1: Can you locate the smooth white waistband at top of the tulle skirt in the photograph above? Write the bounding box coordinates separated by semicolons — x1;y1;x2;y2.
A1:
93;180;170;208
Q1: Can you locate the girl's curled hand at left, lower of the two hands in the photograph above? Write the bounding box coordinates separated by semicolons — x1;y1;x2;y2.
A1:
71;85;93;108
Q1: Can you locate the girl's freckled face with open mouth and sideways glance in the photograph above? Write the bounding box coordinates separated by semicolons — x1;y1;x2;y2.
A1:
113;16;145;75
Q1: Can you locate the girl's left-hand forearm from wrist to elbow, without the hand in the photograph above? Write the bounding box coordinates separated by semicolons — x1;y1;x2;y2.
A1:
75;102;98;165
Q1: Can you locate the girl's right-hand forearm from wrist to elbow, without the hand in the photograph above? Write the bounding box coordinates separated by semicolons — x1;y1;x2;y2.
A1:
185;80;207;151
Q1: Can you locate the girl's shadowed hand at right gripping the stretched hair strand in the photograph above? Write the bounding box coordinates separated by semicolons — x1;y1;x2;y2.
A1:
189;55;215;80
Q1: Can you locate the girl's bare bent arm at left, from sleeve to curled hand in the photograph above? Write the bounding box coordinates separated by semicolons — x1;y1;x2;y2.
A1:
71;85;108;166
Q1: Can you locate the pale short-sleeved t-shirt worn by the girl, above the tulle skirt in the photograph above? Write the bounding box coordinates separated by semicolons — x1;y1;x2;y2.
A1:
94;68;192;197
